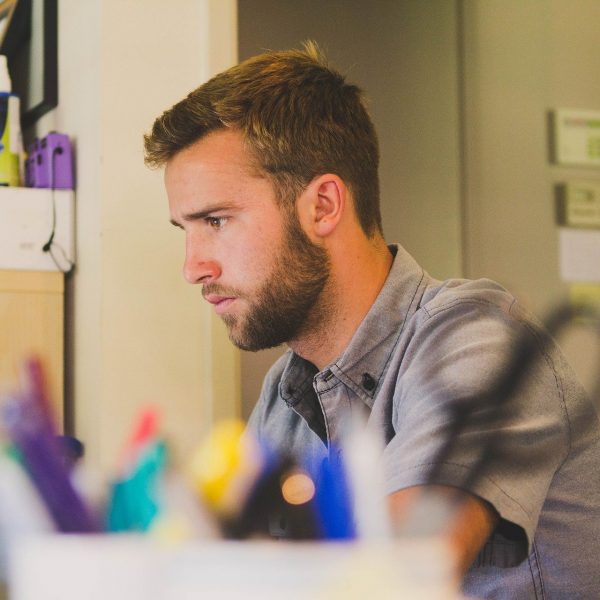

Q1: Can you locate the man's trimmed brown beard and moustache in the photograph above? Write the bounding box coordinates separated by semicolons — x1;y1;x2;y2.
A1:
202;212;331;352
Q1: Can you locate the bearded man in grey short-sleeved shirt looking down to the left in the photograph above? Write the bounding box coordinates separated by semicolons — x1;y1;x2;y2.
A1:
145;44;600;598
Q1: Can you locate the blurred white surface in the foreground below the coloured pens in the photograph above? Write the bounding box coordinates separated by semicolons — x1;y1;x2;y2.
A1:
10;535;459;600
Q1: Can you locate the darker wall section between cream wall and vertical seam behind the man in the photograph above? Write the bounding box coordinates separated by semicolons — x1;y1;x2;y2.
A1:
239;0;462;414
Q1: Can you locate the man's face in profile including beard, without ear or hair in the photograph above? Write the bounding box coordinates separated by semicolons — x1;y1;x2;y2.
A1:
165;130;330;350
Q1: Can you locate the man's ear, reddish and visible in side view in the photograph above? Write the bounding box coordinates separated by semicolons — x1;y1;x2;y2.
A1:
298;174;349;238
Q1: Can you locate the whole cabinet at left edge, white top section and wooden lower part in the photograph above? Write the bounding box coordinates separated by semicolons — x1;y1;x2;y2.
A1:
0;187;75;428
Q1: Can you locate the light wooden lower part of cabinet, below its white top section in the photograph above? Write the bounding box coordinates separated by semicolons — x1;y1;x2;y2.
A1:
0;270;64;427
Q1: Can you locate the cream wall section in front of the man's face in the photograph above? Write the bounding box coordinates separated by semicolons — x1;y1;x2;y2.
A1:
37;0;239;469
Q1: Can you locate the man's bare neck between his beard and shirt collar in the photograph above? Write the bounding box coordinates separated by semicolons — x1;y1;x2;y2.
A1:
288;237;393;370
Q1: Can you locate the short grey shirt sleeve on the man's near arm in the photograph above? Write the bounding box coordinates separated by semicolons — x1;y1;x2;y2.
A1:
384;301;569;555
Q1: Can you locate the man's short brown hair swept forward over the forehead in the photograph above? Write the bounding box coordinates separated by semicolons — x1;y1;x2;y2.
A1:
144;42;382;236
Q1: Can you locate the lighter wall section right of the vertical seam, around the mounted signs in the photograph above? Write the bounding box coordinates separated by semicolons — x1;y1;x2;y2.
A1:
463;0;600;390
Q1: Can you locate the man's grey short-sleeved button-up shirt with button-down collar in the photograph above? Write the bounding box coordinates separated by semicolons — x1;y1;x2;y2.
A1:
249;246;600;600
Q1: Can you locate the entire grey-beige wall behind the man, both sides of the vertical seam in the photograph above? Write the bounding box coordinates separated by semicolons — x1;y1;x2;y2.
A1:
239;0;600;411
